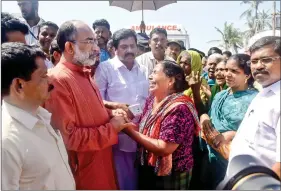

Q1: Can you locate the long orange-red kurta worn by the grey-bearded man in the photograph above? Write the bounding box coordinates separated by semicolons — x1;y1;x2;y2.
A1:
45;63;118;190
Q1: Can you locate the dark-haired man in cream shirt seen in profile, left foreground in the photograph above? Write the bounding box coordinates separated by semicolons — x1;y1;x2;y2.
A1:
1;42;75;190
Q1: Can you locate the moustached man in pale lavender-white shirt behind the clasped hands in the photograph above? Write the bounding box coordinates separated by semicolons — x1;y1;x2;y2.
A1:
95;29;148;190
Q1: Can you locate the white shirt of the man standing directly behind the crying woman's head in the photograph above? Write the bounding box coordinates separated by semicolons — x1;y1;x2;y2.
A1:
136;51;174;78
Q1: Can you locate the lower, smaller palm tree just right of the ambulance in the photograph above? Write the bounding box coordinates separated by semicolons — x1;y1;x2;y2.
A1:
209;22;243;53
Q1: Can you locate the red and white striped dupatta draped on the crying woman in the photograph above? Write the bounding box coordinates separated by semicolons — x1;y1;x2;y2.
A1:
139;93;200;176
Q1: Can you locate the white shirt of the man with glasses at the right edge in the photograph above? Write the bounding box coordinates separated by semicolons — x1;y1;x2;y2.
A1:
227;81;280;174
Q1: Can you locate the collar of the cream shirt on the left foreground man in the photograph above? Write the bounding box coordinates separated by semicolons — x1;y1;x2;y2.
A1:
2;100;52;129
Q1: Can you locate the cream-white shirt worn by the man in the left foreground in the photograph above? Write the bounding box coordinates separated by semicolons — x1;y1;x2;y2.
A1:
2;101;75;190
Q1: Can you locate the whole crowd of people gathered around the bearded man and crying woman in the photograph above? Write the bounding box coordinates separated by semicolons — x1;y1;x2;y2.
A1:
1;0;281;190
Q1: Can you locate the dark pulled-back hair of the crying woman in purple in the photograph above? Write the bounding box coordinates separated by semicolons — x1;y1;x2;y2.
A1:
160;60;188;93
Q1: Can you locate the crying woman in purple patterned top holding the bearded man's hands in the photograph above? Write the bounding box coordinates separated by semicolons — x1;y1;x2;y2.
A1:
124;60;199;190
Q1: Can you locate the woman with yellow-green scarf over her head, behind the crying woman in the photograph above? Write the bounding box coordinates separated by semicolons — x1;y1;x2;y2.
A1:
177;50;211;110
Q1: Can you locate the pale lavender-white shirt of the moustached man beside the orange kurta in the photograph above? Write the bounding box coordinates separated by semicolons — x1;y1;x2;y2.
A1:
95;56;148;107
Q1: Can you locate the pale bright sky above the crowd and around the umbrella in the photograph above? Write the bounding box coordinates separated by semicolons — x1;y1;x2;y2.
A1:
2;1;280;52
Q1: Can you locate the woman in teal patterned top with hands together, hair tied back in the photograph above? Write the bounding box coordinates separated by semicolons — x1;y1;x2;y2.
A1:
200;54;258;189
